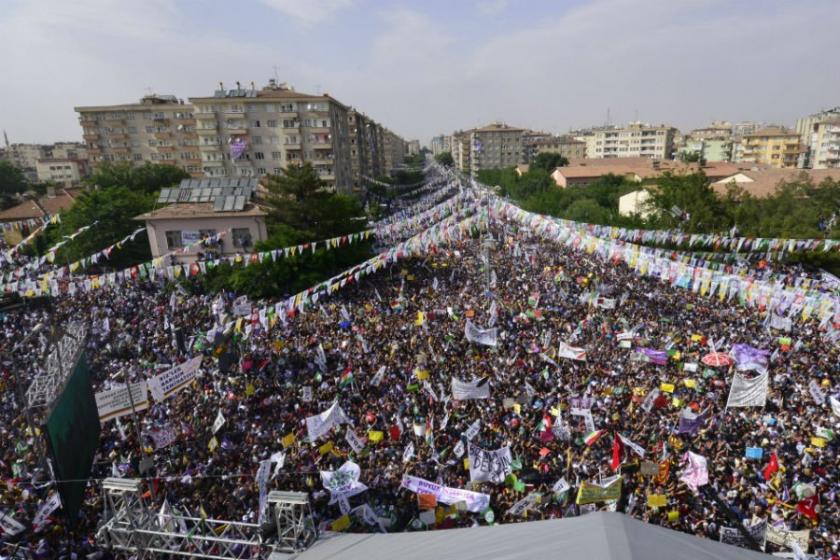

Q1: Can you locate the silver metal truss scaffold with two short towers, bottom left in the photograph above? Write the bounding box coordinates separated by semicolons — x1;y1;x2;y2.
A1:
96;478;317;560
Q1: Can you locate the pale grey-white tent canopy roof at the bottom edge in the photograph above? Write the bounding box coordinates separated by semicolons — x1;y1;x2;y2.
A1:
294;513;769;560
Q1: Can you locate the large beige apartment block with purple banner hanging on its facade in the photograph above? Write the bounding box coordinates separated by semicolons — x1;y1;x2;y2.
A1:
190;80;353;190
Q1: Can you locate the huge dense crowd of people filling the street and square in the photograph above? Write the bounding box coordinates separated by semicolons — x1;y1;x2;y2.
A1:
0;173;840;558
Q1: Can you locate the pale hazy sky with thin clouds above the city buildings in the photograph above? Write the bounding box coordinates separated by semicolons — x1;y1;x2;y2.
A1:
0;0;840;143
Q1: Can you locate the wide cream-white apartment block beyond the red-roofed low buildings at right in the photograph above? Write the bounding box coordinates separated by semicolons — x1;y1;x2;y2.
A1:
578;122;677;159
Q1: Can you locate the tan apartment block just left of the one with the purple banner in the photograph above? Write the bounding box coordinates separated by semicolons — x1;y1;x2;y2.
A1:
75;94;203;177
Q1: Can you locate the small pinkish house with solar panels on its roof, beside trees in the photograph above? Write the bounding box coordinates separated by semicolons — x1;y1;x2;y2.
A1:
134;177;268;264
